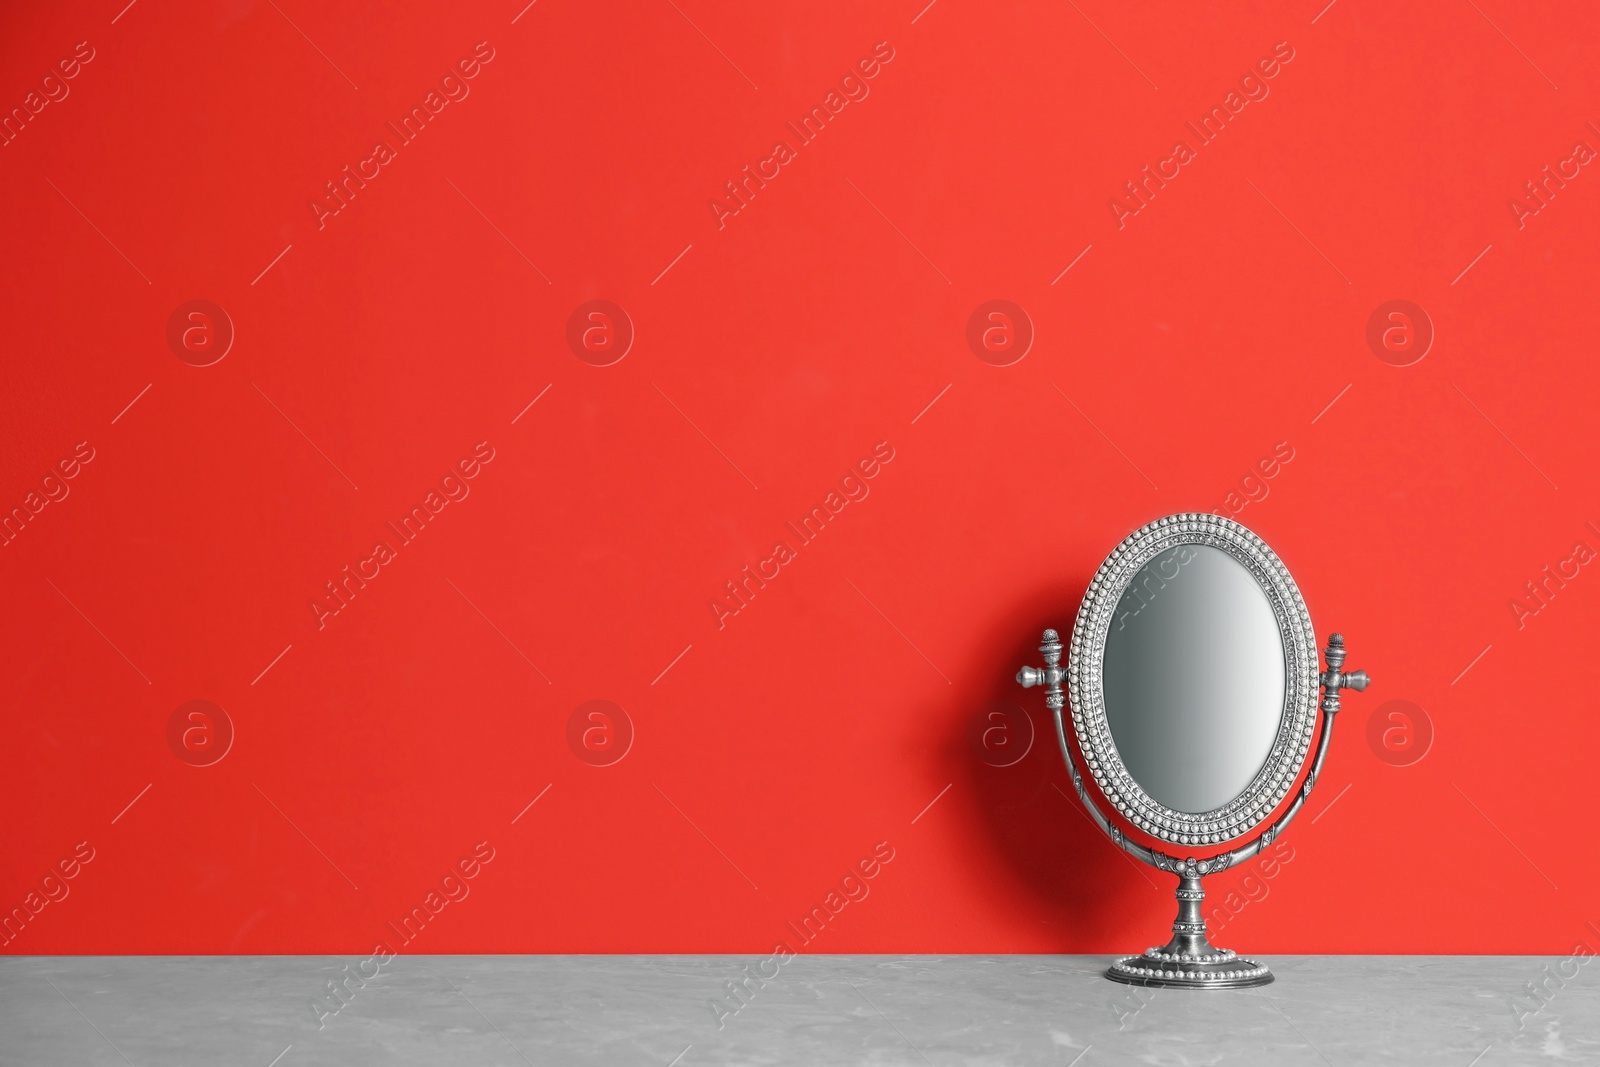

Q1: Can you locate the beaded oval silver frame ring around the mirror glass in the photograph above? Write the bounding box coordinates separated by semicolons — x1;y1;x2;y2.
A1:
1067;512;1320;845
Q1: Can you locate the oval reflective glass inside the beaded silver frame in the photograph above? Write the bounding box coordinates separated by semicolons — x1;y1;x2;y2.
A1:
1104;544;1288;814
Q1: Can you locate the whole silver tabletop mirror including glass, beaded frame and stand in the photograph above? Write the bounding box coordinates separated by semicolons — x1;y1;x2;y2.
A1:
1016;514;1368;989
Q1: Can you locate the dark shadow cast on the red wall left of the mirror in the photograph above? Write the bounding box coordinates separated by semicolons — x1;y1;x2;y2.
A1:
944;573;1173;952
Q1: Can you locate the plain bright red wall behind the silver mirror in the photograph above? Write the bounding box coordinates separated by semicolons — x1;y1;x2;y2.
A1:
0;0;1600;953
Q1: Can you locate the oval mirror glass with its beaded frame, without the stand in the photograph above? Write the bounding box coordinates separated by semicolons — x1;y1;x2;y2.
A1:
1069;515;1317;845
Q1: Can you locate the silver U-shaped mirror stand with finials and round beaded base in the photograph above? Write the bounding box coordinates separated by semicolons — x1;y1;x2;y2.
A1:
1016;630;1370;989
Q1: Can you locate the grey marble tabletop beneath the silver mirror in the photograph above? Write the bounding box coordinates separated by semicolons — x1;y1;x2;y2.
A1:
0;955;1600;1067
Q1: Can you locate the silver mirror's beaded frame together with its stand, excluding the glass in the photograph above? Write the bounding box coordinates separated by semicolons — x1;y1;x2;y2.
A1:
1016;512;1370;989
